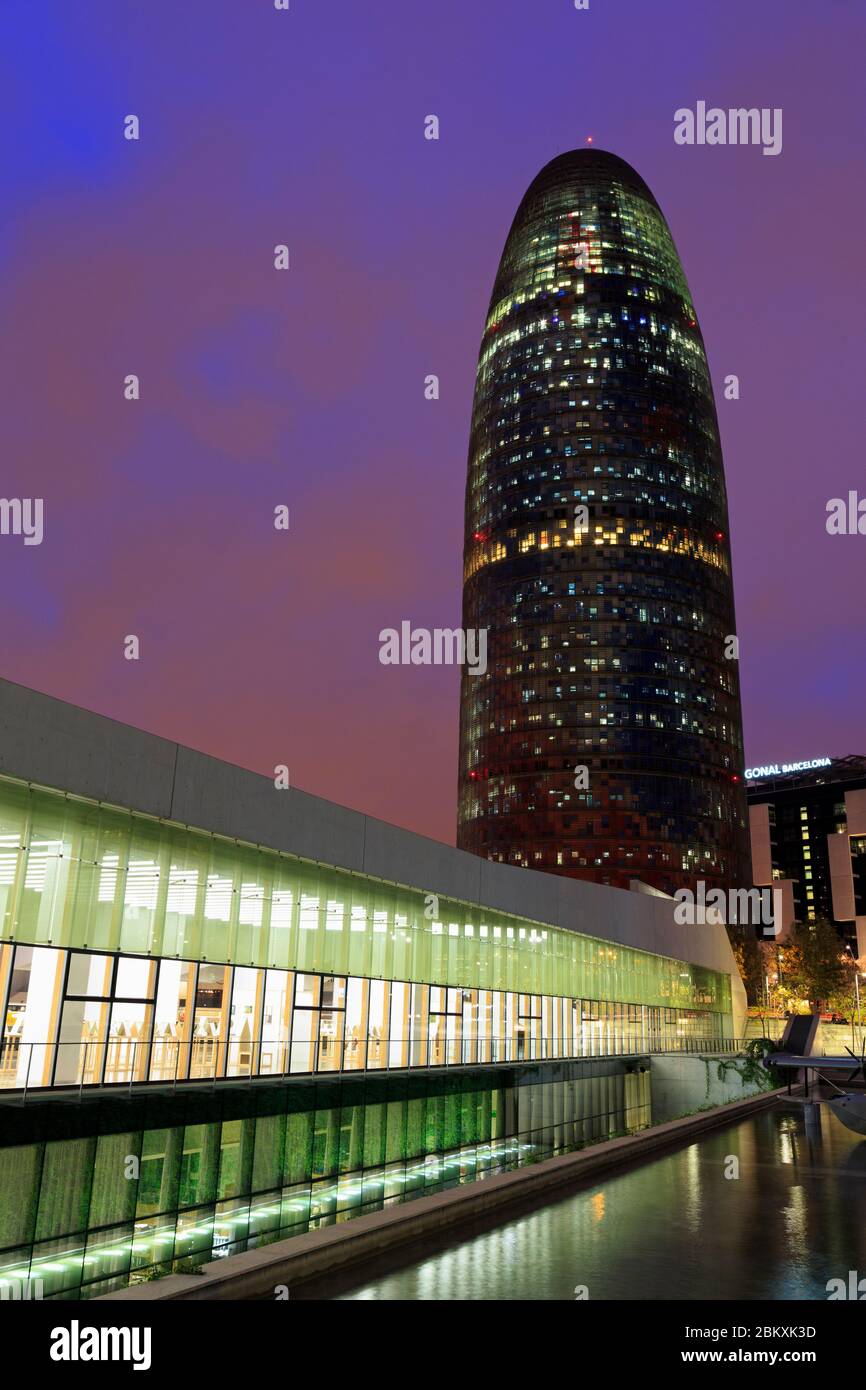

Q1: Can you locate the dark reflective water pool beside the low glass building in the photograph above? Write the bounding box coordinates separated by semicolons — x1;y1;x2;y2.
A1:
330;1104;866;1300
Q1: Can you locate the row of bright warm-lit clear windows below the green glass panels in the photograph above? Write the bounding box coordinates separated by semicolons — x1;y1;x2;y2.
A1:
0;945;728;1091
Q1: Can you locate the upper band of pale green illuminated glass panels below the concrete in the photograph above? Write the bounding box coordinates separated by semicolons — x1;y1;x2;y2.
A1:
0;778;730;1017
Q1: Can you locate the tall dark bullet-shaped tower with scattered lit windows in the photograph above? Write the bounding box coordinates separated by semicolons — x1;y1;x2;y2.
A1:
457;149;751;892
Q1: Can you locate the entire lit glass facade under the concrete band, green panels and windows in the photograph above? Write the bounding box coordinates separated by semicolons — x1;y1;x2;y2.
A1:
0;778;731;1088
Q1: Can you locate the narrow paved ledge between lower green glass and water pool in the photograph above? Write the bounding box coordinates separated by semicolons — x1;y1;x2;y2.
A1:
96;1088;785;1302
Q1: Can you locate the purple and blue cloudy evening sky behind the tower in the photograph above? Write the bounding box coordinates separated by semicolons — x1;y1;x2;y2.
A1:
0;0;866;841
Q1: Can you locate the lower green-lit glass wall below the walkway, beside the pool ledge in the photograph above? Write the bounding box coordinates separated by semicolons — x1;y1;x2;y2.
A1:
0;1062;651;1298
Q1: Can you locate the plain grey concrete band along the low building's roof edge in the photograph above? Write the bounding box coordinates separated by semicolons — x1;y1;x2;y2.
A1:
0;680;745;1011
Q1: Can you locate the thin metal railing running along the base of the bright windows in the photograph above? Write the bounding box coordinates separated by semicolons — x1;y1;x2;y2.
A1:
0;1030;751;1098
